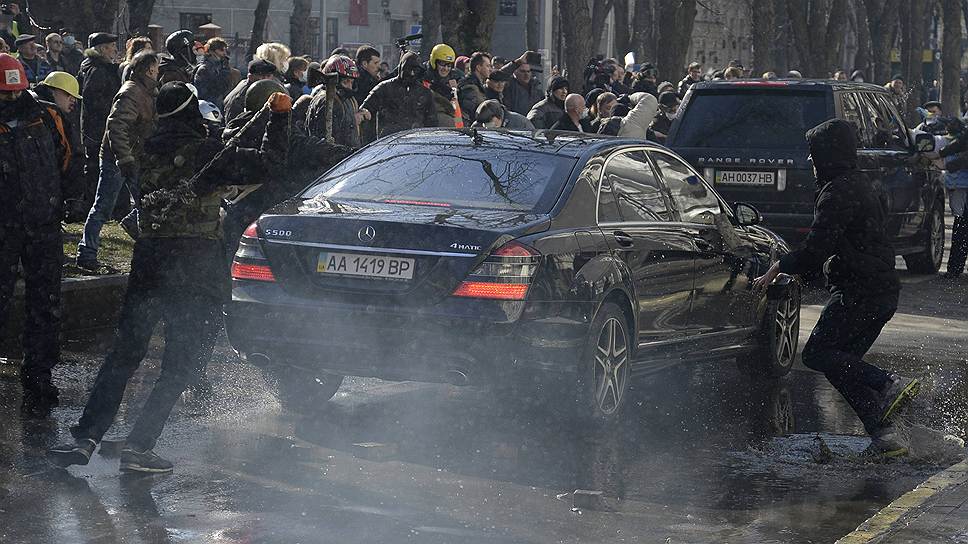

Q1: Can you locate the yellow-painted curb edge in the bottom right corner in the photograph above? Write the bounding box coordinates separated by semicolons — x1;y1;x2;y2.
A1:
836;459;968;544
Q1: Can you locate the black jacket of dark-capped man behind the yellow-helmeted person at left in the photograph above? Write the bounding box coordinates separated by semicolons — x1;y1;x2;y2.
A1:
77;49;121;159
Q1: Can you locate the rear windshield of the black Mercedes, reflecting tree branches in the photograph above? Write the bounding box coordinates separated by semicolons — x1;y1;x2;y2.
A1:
302;144;576;213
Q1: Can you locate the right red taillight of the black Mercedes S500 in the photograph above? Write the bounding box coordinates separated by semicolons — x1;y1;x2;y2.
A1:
453;241;541;300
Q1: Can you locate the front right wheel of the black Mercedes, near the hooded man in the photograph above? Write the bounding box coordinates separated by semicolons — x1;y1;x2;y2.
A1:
737;280;800;378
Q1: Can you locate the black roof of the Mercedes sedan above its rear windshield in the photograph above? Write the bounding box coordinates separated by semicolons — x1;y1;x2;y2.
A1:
371;128;668;159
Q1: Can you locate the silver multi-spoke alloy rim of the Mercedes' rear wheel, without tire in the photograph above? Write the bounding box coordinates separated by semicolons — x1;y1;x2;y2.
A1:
595;317;629;415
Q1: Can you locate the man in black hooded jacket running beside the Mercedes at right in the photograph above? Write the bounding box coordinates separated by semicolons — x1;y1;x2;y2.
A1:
755;119;920;457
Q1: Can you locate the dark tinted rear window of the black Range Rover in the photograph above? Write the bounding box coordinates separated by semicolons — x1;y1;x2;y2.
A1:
670;90;830;149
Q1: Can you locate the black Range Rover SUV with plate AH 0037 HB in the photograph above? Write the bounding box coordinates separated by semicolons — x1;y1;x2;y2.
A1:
667;80;945;274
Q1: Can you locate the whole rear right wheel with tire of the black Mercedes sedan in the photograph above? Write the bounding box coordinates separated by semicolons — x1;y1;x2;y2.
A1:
576;302;634;422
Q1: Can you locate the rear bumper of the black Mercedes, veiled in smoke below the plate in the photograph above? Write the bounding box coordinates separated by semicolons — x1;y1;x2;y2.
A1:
225;284;588;383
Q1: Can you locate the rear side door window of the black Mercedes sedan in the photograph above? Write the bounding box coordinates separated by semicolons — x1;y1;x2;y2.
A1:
605;151;671;222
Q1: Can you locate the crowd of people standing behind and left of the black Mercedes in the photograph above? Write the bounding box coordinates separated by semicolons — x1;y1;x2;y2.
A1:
0;19;968;472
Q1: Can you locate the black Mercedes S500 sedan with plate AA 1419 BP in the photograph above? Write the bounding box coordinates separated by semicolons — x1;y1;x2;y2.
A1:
225;129;800;418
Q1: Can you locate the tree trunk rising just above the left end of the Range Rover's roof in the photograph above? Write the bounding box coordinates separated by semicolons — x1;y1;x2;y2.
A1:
655;0;698;81
